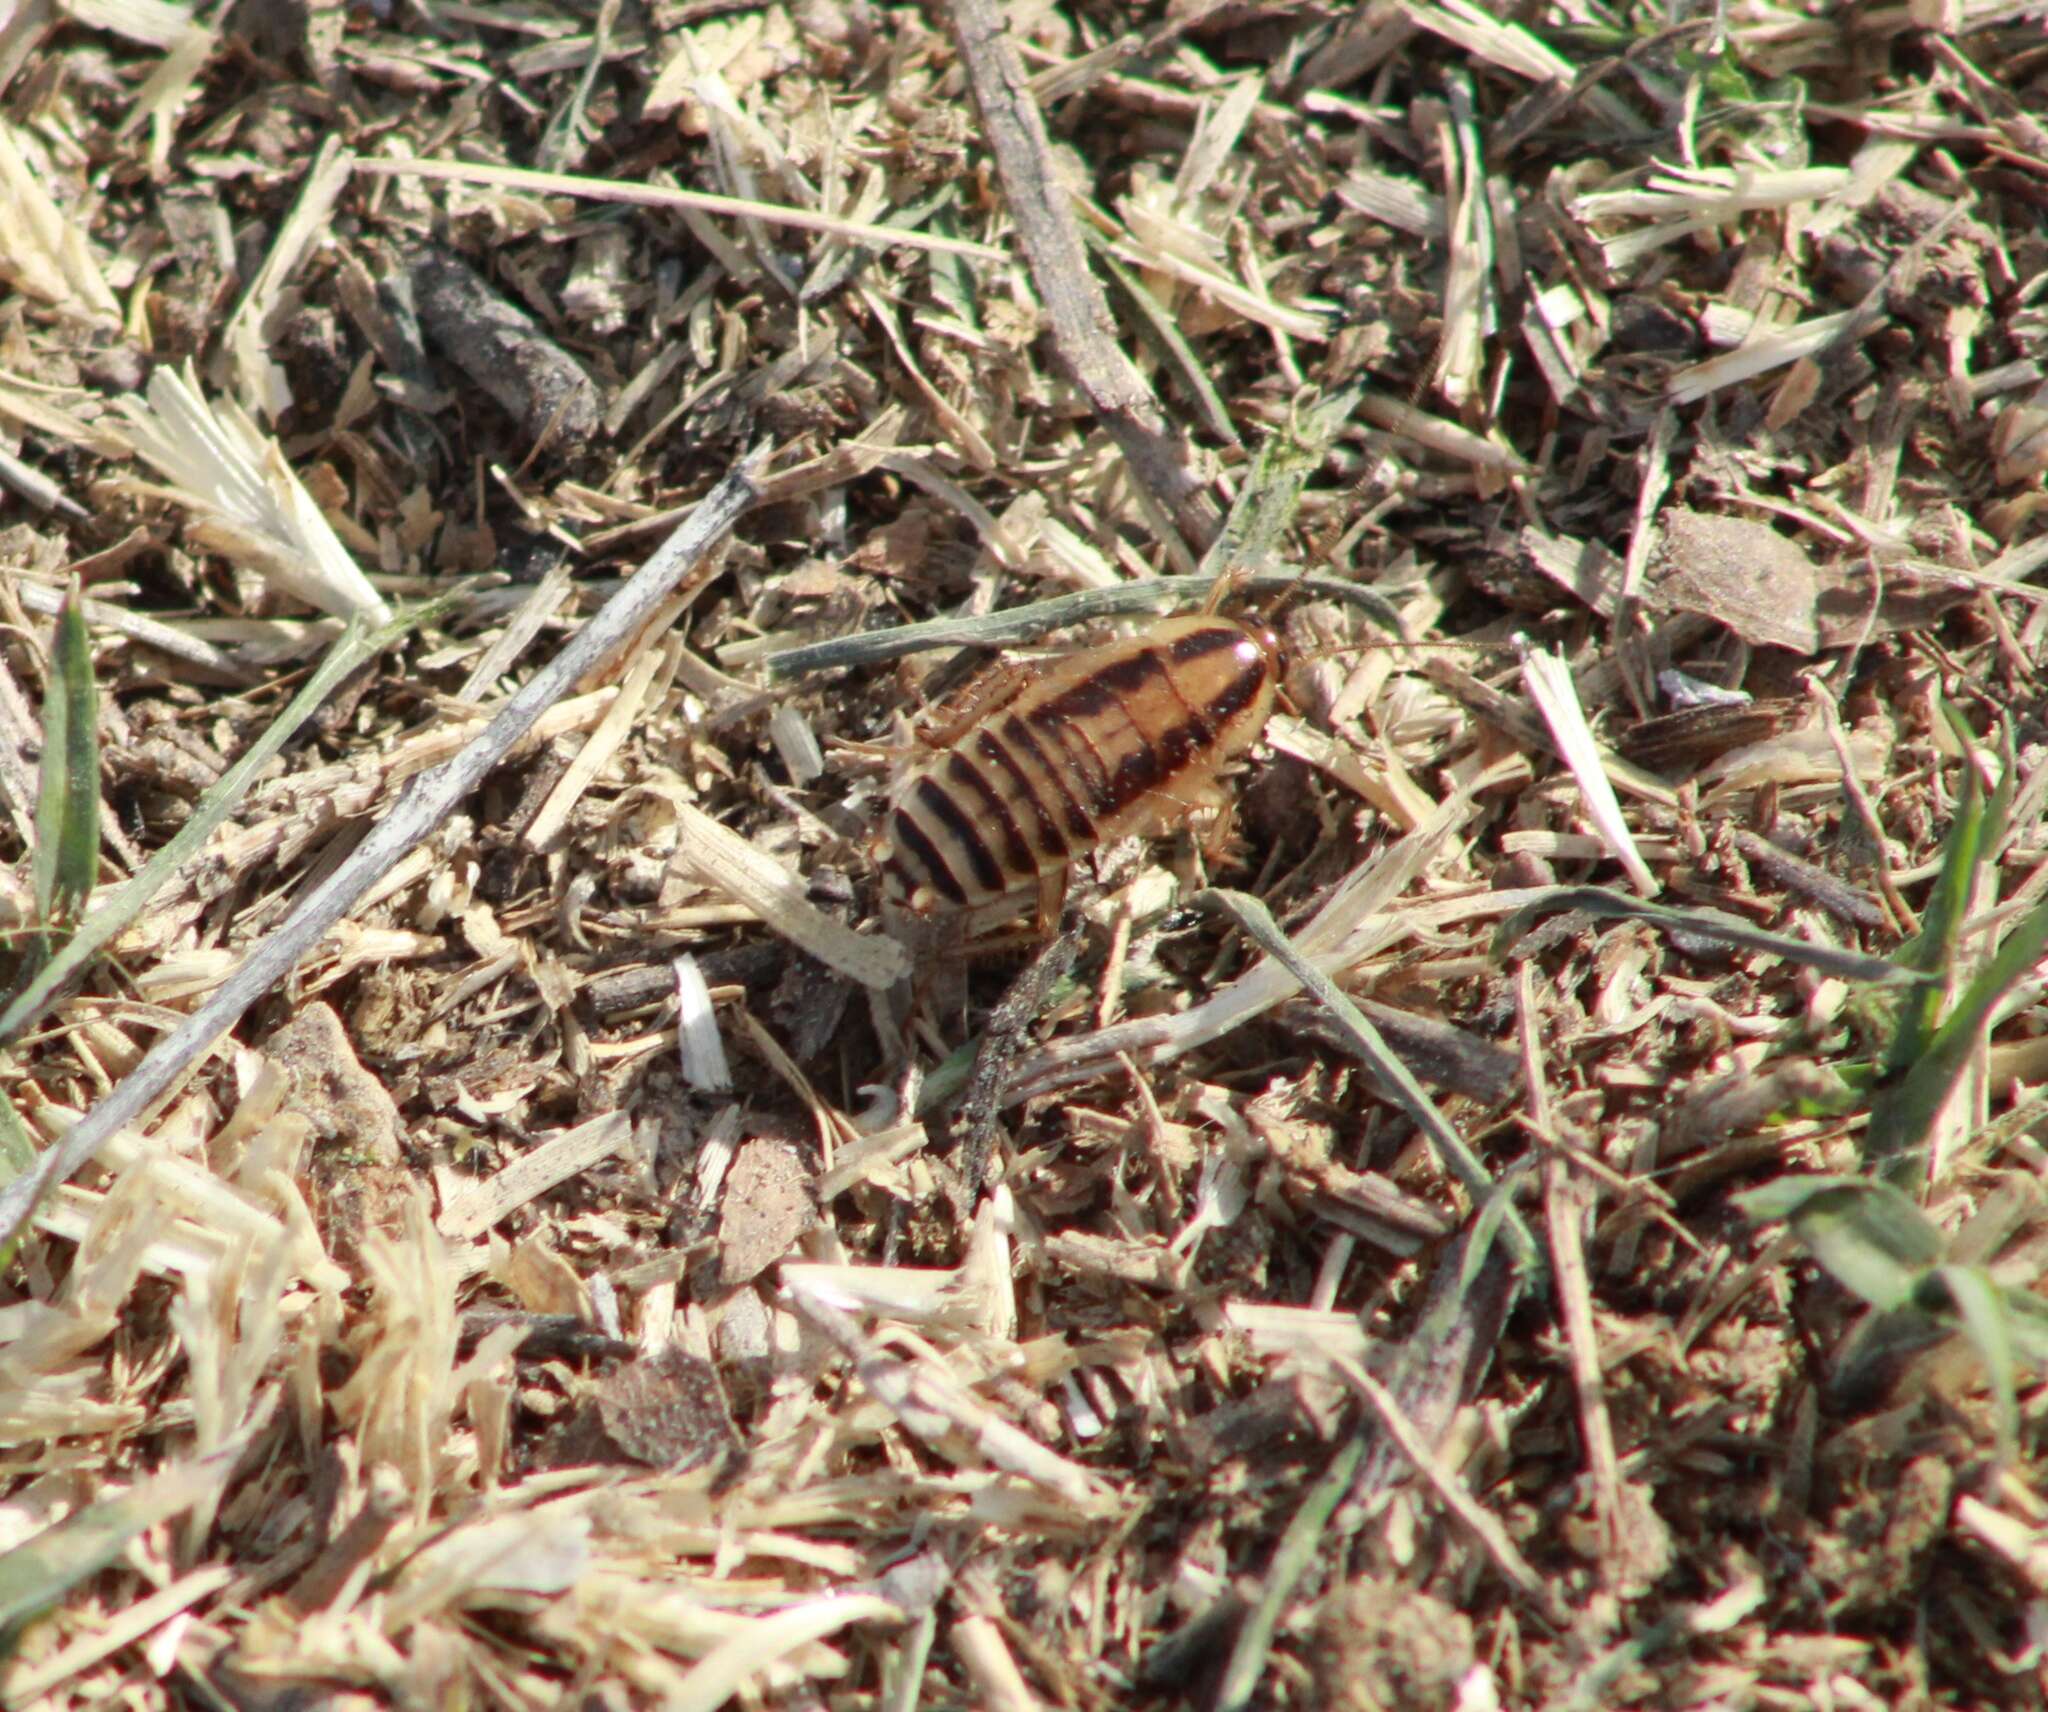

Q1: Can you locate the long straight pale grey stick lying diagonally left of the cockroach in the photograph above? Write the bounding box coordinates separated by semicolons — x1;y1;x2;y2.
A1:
0;467;756;1245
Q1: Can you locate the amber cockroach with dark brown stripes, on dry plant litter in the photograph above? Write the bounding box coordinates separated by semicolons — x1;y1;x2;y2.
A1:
879;616;1280;909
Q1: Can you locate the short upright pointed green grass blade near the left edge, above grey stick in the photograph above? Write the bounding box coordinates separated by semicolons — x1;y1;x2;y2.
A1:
33;588;100;954
